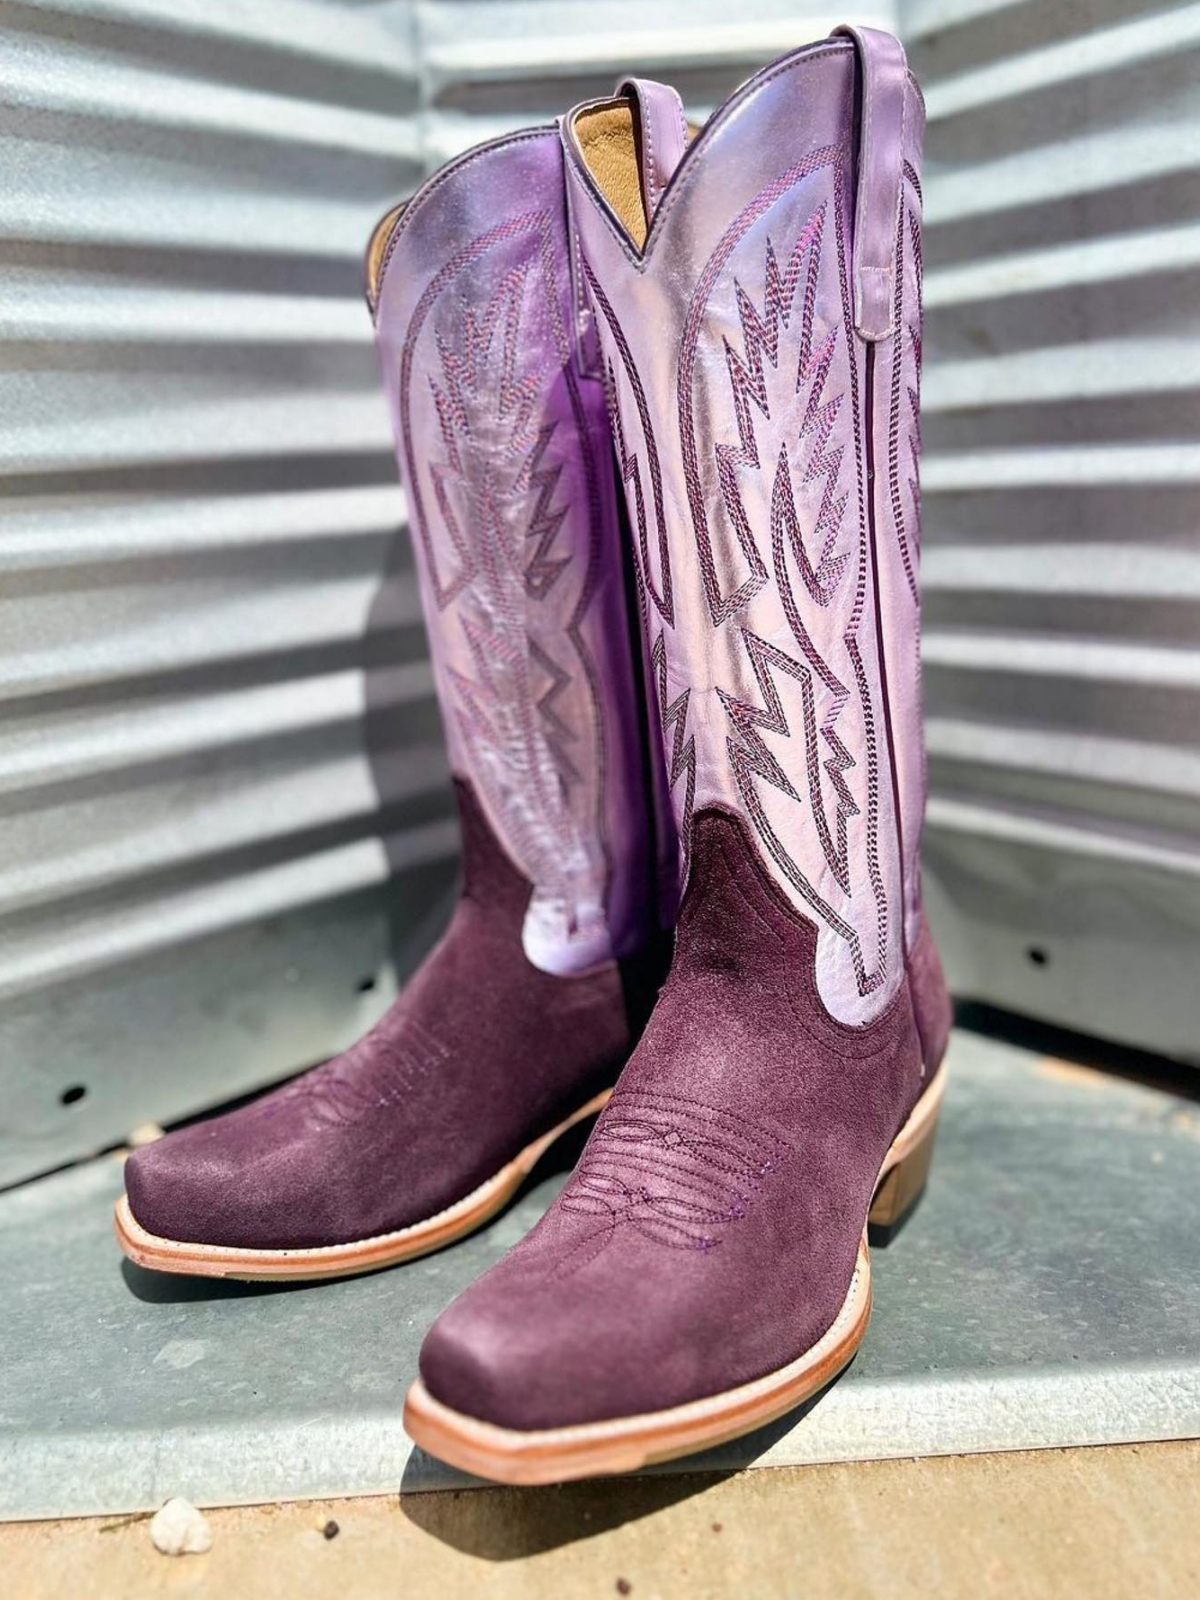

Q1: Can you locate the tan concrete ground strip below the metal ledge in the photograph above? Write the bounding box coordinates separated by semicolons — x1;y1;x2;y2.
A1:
0;1442;1200;1600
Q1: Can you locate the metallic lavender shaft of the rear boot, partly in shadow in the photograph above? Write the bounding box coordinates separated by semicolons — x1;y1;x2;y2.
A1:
376;128;684;973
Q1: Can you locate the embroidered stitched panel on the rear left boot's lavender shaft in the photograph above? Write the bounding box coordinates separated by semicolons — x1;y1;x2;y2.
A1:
400;200;608;939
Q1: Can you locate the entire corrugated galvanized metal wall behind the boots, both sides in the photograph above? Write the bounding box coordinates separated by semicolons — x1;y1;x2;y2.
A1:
0;0;1200;1181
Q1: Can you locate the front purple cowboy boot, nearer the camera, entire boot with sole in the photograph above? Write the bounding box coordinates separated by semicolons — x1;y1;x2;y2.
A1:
405;30;950;1483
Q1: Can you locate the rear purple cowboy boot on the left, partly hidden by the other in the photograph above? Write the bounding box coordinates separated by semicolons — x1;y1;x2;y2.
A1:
117;100;694;1278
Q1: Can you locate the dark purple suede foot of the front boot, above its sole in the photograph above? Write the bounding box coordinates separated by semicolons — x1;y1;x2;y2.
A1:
421;821;922;1429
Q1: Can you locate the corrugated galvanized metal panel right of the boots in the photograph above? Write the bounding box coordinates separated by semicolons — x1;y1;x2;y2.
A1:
901;0;1200;1059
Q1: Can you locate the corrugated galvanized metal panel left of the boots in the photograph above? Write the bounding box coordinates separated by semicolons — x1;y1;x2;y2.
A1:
0;0;454;1182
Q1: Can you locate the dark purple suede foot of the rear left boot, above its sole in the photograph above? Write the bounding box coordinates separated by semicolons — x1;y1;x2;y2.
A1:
126;899;629;1250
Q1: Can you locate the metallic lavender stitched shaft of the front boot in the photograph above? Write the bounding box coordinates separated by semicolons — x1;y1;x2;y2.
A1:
566;28;923;1024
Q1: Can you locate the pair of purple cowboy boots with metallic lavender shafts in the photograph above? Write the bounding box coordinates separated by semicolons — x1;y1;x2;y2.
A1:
118;29;950;1483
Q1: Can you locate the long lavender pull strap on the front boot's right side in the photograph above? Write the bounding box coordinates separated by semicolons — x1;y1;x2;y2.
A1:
834;22;909;342
